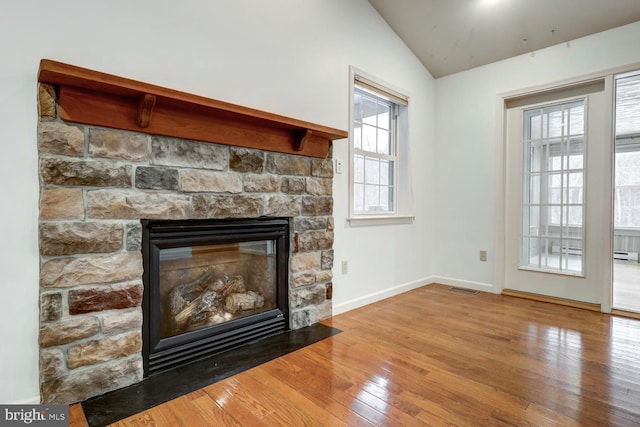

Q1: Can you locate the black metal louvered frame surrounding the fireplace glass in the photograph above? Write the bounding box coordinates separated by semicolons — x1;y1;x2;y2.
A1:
141;217;290;377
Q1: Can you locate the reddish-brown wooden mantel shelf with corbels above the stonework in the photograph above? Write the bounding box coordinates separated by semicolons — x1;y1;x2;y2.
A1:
38;59;348;158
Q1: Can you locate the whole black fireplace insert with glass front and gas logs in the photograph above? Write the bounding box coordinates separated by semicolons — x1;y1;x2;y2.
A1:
142;218;289;376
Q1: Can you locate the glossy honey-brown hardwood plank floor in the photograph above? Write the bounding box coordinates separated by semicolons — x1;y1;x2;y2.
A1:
71;285;640;427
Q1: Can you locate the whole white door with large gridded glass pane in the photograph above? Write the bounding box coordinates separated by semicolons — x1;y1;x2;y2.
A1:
504;79;613;304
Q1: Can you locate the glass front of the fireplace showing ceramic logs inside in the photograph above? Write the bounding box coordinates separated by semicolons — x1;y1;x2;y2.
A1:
159;240;277;338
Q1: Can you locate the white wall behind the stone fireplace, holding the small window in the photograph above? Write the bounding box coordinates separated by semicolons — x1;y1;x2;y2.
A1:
0;0;435;403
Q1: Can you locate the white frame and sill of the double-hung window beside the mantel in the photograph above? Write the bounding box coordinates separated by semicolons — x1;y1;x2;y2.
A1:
348;67;414;226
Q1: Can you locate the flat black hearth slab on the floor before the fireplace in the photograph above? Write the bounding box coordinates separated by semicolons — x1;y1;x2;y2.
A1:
82;324;341;427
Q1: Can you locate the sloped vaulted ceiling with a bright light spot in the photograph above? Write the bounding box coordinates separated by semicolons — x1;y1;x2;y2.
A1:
369;0;640;77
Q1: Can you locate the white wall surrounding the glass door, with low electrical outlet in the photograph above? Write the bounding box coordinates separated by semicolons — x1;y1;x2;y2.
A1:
435;23;640;292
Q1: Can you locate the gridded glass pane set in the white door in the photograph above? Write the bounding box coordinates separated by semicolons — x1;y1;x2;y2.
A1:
520;100;585;273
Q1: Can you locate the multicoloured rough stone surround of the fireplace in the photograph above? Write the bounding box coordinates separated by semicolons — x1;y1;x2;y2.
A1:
38;85;334;403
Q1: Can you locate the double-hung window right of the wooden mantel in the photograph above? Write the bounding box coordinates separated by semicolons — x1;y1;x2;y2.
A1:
350;69;409;224
